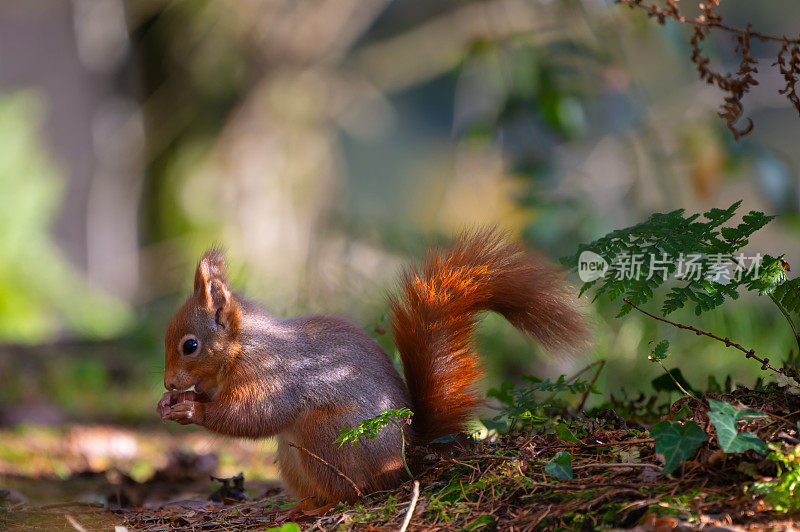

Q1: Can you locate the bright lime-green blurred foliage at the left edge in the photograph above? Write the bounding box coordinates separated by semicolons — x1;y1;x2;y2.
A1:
0;92;132;343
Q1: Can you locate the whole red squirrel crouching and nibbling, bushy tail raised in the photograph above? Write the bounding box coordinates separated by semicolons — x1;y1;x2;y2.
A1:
158;230;588;507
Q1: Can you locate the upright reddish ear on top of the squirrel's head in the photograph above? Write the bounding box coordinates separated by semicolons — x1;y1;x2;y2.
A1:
194;248;239;330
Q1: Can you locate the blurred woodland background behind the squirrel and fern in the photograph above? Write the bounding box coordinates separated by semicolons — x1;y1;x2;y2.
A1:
0;0;800;426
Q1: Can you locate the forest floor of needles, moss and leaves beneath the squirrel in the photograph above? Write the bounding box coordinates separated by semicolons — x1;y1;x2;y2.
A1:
0;387;800;532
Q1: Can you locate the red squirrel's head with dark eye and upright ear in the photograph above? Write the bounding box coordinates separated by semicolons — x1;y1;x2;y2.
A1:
164;248;241;401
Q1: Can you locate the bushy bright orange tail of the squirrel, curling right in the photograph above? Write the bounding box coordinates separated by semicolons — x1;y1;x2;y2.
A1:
390;230;587;442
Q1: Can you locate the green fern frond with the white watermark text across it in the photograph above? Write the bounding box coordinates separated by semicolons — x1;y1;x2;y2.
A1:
562;201;780;316
